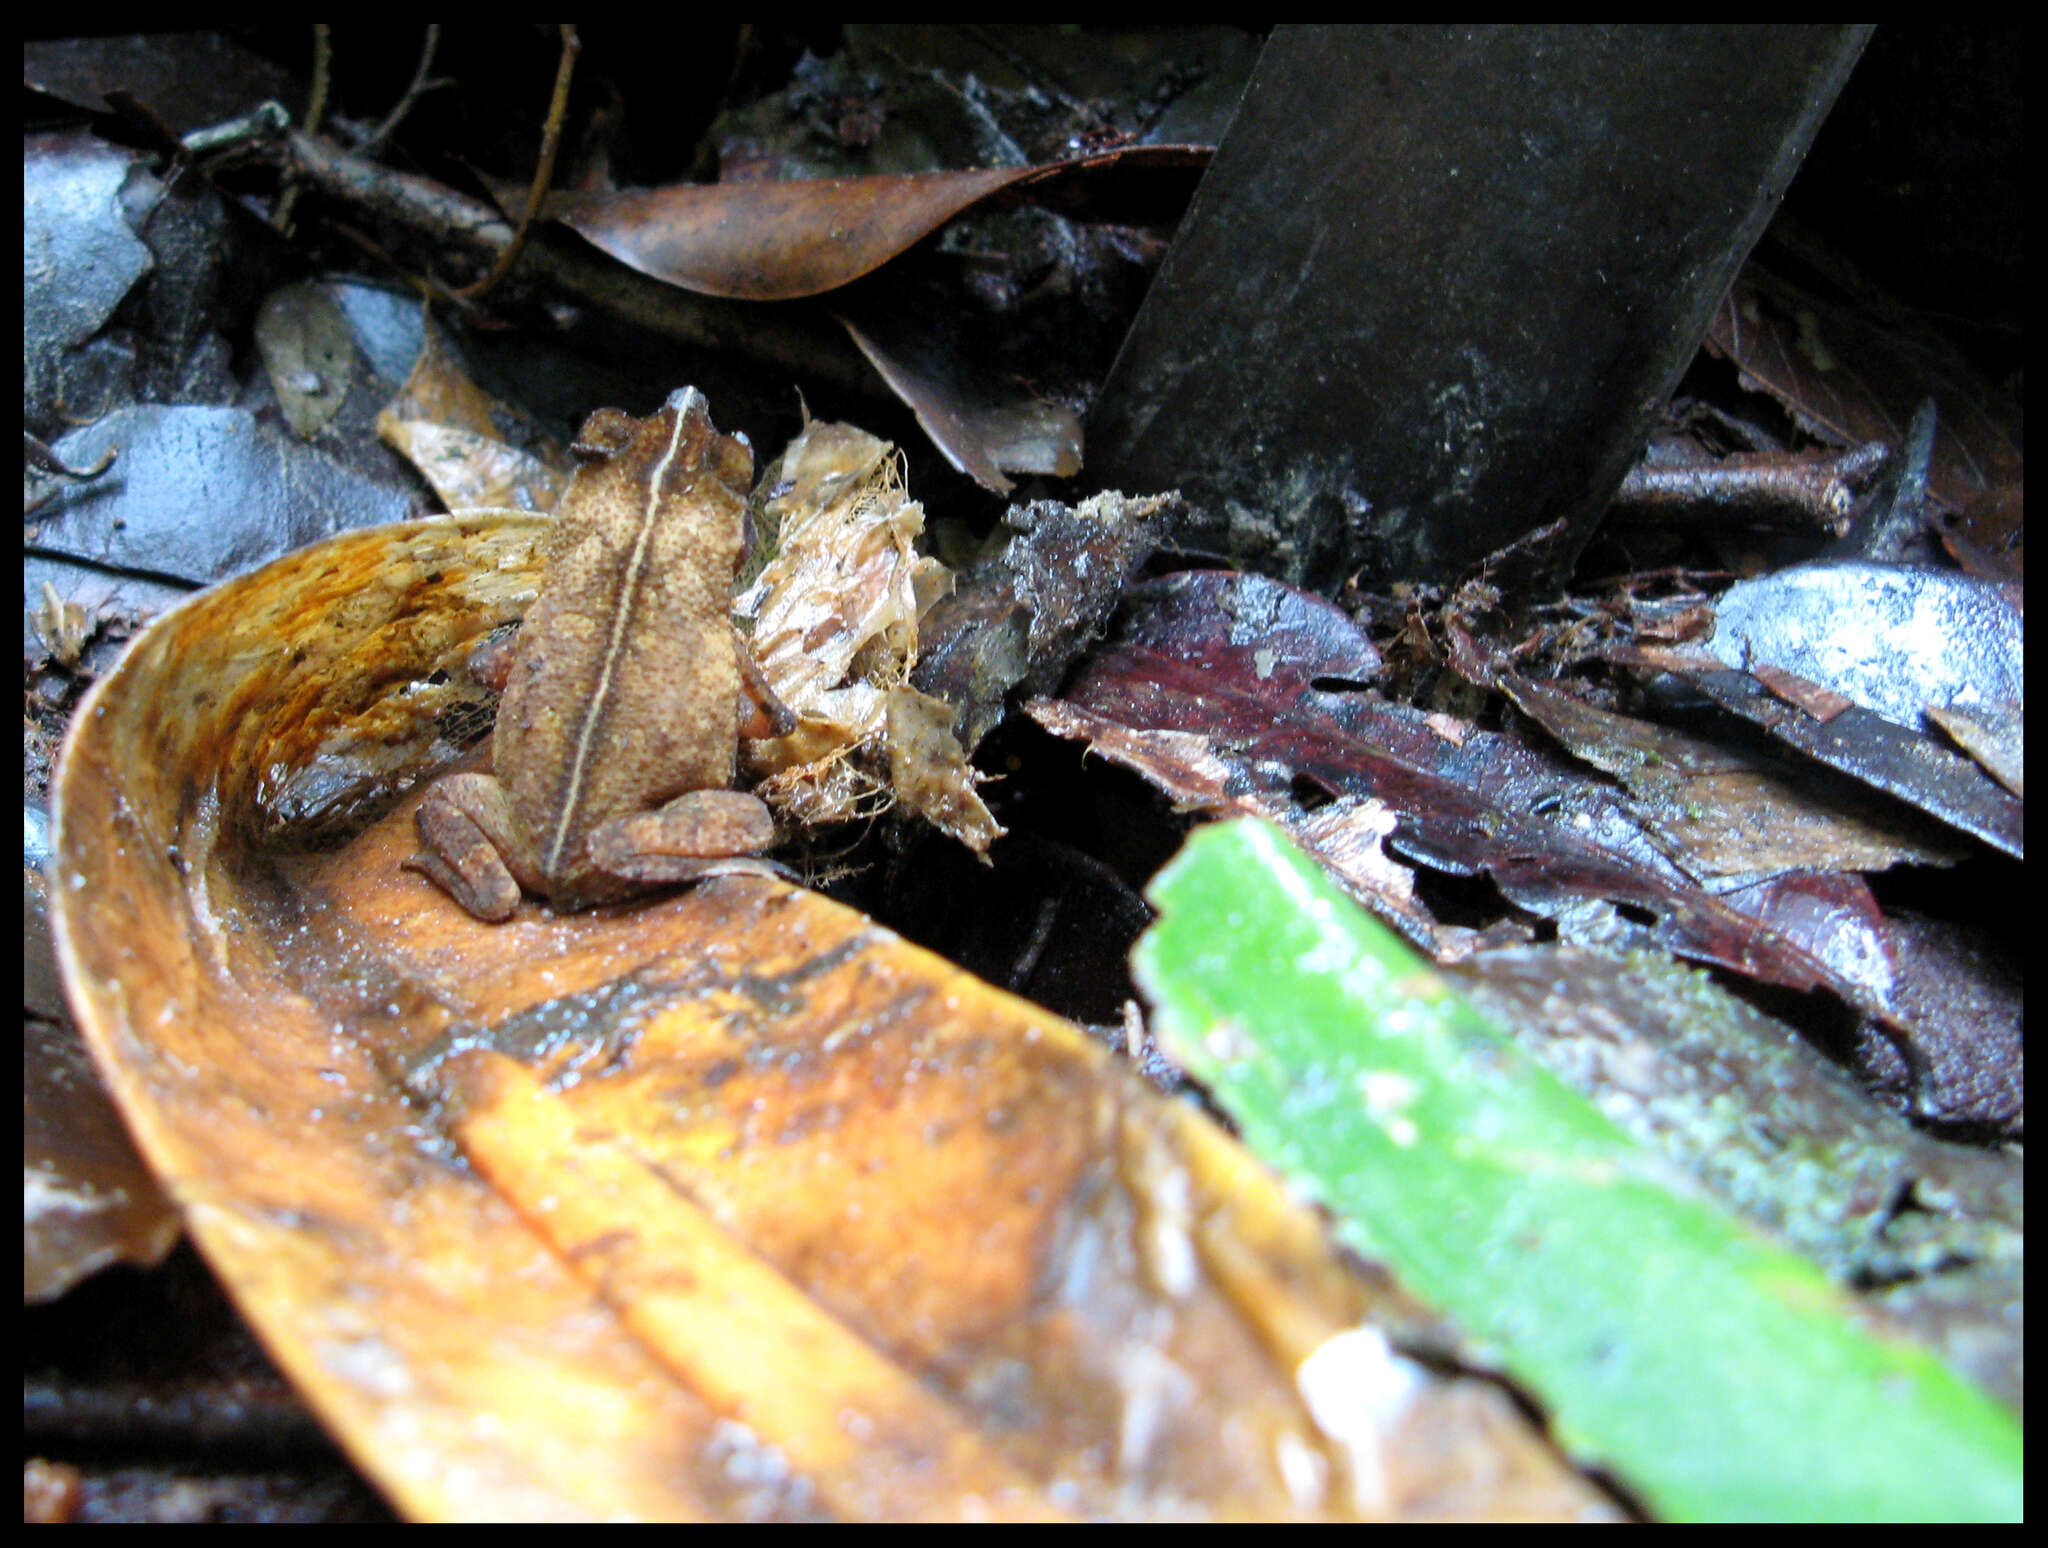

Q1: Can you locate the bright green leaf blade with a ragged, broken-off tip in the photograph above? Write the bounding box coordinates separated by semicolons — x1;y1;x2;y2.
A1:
1133;821;2023;1521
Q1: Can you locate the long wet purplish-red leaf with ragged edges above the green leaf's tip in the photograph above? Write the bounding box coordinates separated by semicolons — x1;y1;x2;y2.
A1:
1040;573;1827;987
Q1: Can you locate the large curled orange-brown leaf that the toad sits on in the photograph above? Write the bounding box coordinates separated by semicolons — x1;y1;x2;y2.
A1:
55;512;1604;1519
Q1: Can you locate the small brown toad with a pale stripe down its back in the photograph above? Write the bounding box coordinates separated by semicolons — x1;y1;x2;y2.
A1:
408;387;795;919
